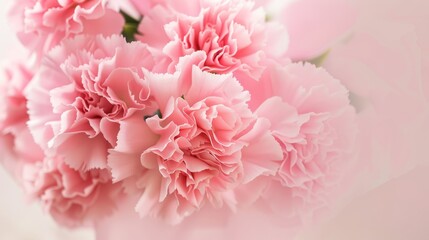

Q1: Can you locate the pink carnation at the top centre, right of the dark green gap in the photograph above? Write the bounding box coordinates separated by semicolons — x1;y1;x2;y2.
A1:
137;0;287;79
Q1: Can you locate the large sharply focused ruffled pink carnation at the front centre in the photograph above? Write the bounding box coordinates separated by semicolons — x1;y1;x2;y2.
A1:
109;52;282;223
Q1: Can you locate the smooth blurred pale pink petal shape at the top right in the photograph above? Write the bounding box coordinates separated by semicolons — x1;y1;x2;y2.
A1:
273;0;356;60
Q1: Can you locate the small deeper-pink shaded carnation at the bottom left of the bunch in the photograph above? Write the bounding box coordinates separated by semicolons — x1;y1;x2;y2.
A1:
23;158;119;227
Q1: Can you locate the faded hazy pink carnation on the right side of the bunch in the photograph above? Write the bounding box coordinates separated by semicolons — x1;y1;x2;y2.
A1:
241;64;356;223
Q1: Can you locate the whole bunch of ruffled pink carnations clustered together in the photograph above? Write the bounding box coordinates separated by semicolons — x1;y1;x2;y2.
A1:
0;0;356;229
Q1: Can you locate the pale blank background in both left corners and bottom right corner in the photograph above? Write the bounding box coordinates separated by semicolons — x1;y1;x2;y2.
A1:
0;0;429;240
